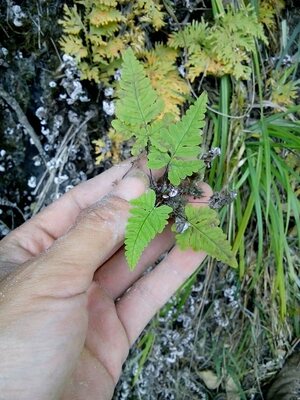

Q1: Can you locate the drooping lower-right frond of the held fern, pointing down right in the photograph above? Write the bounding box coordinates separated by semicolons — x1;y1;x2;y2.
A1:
176;205;237;268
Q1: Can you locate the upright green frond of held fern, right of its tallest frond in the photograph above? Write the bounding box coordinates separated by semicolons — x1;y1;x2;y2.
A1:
148;93;207;186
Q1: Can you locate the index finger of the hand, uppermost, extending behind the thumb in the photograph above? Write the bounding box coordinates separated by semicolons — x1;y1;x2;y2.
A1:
0;160;139;268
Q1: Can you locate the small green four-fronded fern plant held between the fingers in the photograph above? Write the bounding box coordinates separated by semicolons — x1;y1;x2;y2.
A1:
112;49;237;269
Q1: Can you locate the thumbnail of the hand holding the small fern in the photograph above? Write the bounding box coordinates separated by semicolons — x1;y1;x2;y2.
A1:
113;170;149;201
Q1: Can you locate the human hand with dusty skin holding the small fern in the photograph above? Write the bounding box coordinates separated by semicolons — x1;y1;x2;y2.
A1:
0;162;212;400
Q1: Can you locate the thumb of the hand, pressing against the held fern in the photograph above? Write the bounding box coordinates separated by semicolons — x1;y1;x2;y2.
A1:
30;170;149;297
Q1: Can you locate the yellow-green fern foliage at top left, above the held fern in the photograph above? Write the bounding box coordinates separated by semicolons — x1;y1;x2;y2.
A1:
60;0;164;82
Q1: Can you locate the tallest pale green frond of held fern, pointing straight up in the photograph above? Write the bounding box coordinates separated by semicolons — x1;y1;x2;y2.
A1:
112;49;163;148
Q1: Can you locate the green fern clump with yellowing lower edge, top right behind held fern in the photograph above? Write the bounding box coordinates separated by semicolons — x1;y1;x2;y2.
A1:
168;5;267;82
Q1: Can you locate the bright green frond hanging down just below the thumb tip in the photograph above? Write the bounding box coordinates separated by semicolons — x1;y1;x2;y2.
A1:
125;189;172;270
